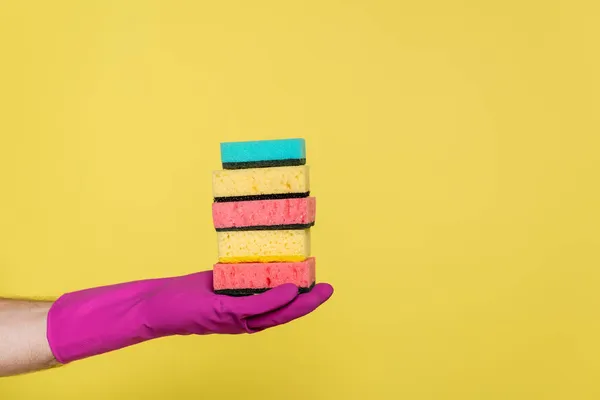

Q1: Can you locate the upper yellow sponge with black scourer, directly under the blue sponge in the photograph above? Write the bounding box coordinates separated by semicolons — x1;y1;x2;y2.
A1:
213;165;310;201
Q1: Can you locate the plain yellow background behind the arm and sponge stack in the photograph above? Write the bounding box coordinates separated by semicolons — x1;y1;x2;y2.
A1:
0;0;600;400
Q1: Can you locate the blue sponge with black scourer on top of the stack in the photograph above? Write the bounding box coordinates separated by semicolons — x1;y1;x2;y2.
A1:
221;139;306;169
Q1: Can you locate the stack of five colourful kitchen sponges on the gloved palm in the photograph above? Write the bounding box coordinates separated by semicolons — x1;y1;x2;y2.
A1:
212;139;316;296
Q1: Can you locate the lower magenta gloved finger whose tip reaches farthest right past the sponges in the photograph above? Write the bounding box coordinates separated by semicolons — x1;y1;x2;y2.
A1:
246;283;333;332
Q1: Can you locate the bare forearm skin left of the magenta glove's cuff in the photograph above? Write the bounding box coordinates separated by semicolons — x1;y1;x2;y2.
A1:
0;298;58;376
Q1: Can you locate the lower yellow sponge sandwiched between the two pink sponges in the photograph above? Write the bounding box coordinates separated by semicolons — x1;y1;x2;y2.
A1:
217;229;310;263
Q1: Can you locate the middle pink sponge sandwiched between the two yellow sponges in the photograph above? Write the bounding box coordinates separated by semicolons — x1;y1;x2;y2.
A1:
212;197;316;232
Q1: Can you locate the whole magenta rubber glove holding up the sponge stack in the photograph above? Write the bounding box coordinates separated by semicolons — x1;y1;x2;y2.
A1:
47;271;333;364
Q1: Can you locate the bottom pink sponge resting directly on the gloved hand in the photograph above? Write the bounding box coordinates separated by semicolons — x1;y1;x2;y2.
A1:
213;257;315;296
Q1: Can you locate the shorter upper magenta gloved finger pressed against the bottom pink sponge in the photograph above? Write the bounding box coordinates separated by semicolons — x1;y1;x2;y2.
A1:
228;283;298;318
